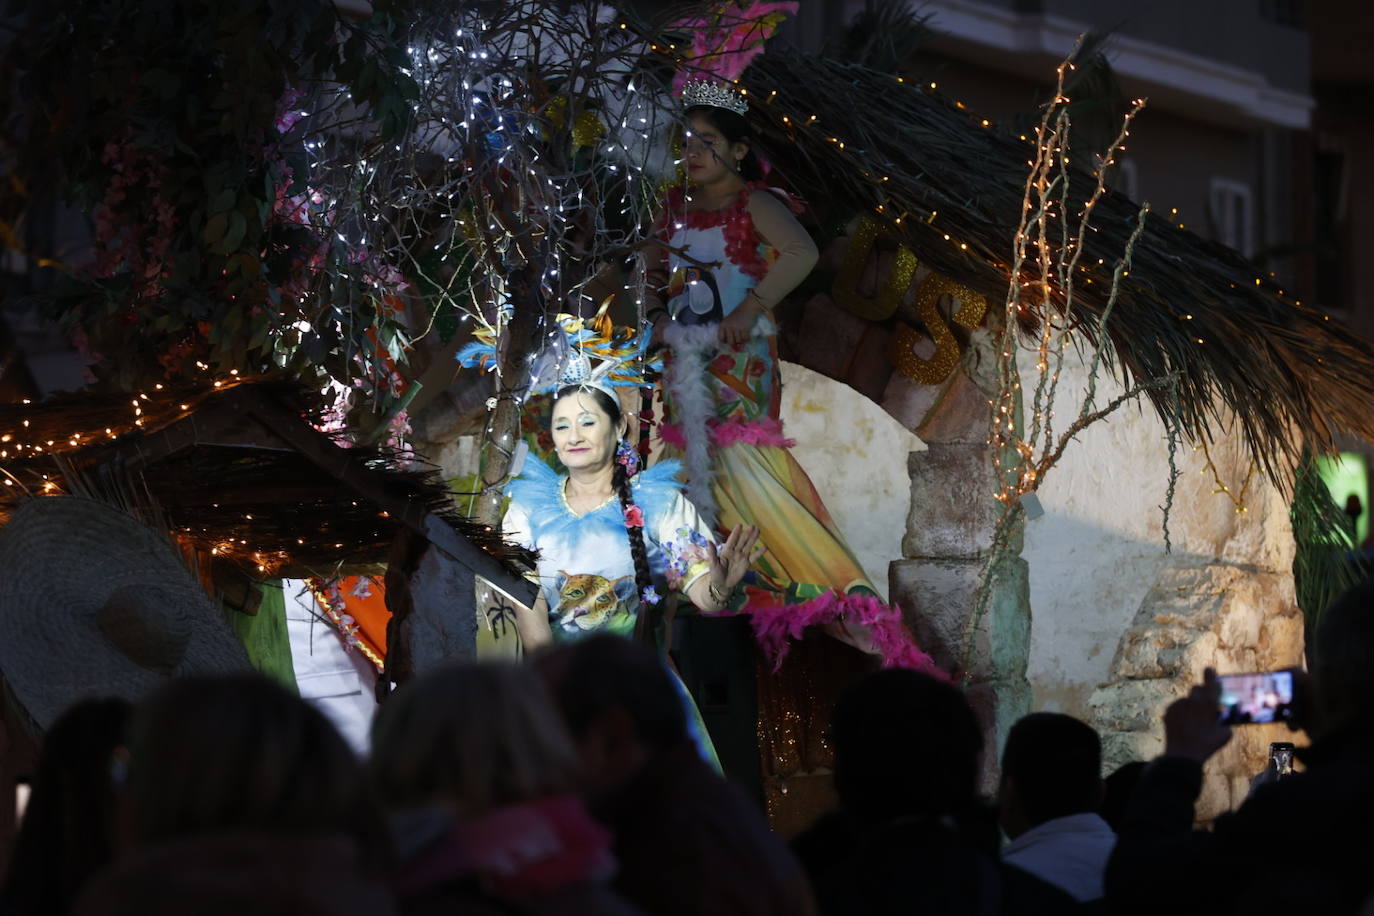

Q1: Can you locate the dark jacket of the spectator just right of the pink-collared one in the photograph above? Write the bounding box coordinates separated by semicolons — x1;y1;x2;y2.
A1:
594;743;815;916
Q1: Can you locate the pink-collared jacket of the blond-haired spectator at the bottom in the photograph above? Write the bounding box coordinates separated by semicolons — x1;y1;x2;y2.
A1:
394;797;640;916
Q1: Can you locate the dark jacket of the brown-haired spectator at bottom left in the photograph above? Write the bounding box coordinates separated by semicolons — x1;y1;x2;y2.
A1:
73;832;396;916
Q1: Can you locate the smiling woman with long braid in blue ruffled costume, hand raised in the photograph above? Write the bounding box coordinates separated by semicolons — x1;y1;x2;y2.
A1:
503;382;763;766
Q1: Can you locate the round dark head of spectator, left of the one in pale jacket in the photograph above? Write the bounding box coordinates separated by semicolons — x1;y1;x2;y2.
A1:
830;669;982;821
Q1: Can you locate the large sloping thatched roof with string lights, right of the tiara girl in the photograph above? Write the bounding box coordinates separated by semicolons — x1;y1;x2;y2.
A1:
745;51;1374;478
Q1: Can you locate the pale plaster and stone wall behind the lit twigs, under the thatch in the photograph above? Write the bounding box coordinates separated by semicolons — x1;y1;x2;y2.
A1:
1022;351;1303;817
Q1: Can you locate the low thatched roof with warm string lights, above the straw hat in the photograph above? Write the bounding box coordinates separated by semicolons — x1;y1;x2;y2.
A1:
0;380;530;580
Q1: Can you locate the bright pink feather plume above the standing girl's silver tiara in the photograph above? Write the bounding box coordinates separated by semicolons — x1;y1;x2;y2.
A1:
673;0;801;106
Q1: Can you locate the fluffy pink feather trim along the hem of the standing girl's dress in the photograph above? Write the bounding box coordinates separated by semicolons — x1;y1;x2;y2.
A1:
742;591;949;681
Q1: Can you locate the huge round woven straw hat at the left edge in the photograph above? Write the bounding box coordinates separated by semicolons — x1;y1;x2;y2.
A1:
0;496;251;729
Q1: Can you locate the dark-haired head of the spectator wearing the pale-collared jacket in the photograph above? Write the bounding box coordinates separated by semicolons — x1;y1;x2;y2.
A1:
1000;713;1102;839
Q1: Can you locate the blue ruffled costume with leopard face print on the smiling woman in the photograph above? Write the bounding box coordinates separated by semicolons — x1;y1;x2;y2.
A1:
502;453;720;769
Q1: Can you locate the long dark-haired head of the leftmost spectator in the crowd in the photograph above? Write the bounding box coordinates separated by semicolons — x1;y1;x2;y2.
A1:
3;699;129;913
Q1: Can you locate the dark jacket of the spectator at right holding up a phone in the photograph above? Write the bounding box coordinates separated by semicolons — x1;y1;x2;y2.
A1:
1106;722;1374;916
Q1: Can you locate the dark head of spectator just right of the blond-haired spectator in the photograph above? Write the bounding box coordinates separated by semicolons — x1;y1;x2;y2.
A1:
539;636;688;795
